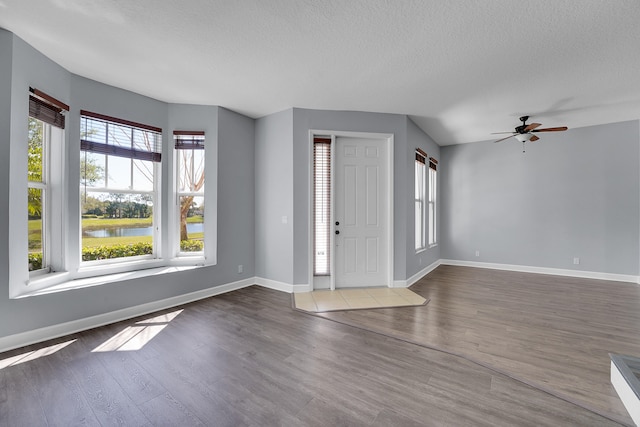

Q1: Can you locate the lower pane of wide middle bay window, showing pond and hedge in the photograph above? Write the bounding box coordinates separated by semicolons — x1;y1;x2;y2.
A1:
81;191;153;261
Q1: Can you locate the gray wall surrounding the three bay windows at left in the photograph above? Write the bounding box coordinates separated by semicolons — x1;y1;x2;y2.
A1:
0;30;255;337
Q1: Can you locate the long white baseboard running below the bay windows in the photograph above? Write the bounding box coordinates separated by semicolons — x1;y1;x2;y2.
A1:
0;277;256;352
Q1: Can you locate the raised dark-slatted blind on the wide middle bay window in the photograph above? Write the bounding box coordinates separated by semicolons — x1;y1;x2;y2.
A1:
80;110;162;162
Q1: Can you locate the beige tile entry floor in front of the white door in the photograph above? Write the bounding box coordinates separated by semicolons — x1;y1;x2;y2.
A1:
294;288;427;313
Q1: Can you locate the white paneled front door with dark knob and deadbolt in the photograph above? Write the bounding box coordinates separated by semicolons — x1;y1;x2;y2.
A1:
334;137;390;288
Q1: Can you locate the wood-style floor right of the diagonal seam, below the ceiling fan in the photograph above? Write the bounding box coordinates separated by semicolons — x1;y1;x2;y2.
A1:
319;266;640;425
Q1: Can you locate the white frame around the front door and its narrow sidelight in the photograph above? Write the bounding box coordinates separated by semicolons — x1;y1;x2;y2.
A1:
307;129;394;291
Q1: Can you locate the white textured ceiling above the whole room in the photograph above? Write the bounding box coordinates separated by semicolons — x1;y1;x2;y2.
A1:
0;0;640;145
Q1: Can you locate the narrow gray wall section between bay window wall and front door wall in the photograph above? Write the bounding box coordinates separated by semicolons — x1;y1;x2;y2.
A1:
255;110;296;284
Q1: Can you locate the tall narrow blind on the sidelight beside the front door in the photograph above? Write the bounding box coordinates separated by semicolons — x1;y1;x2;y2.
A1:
313;138;331;276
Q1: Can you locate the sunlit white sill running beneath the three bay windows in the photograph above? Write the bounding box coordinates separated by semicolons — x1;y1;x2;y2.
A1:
19;265;204;298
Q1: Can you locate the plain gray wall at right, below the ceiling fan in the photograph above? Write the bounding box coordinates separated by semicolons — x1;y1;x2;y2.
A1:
440;121;640;275
